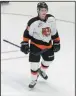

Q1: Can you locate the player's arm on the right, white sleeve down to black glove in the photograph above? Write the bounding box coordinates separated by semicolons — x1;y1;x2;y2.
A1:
51;17;60;52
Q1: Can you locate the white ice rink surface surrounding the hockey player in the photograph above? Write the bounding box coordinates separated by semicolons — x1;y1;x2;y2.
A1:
1;2;75;96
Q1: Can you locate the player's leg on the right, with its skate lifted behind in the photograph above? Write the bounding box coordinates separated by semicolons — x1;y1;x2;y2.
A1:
39;48;54;79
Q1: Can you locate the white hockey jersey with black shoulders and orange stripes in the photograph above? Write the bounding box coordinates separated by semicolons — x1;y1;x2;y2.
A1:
23;14;60;49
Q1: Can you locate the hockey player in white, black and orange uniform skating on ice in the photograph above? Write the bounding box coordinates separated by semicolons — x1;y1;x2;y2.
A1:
21;2;60;88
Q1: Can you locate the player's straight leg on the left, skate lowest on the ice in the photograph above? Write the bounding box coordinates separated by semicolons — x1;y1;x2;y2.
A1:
29;45;40;88
